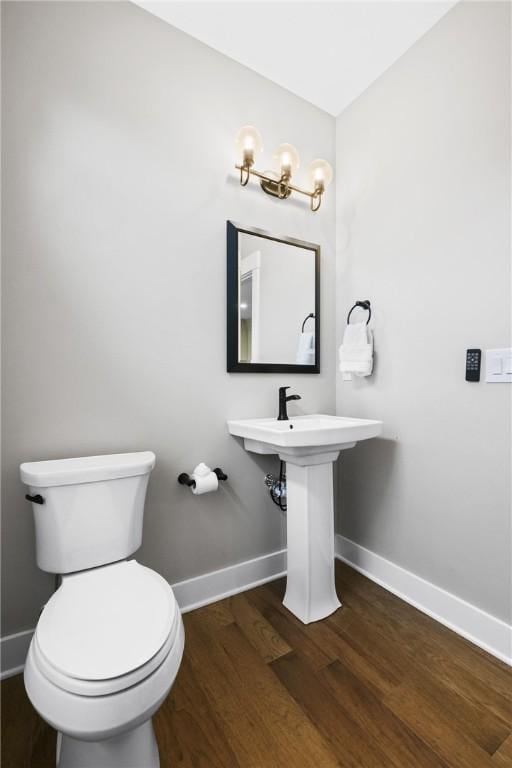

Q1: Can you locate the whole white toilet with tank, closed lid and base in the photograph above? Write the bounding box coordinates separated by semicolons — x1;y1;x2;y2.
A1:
20;451;184;768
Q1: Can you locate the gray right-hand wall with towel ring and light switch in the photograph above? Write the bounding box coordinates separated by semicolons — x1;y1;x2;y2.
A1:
337;2;511;621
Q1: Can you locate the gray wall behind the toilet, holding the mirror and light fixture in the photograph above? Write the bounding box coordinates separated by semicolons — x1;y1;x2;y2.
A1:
2;2;335;634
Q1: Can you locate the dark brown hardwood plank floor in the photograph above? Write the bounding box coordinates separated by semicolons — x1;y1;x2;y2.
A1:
2;563;512;768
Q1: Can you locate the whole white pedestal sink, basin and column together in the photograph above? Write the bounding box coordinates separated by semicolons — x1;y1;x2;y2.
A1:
228;414;382;624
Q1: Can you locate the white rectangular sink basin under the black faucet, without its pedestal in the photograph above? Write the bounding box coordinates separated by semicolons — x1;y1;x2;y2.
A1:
228;413;382;456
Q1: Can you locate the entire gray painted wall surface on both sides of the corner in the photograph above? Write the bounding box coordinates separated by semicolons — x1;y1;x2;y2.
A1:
2;2;511;634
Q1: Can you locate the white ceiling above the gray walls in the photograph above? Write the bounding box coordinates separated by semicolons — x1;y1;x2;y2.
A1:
136;0;455;115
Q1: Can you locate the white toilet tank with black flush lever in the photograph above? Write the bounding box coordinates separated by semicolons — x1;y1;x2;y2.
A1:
20;451;155;573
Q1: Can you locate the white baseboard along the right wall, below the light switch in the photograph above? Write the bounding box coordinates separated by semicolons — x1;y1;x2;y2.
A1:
335;534;512;666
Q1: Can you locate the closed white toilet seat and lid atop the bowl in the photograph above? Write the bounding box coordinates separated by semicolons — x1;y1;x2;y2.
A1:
33;560;181;696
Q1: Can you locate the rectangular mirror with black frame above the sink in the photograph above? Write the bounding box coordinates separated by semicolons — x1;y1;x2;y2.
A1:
227;221;320;373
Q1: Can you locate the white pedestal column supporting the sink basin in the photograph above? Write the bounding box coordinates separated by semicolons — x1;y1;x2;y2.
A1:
280;451;341;624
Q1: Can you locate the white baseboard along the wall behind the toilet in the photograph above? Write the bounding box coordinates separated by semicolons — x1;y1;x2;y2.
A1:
0;549;286;680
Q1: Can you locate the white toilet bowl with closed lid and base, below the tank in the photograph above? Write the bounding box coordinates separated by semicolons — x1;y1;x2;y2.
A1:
25;560;184;768
